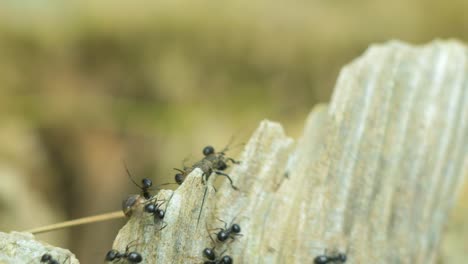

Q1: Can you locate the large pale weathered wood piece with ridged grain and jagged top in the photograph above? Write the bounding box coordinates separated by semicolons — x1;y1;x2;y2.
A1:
114;41;468;263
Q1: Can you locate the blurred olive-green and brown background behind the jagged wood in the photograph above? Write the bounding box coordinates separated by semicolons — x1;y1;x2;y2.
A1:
0;0;468;263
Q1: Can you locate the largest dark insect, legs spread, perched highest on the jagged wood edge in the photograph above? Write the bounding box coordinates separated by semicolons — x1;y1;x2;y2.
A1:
174;146;240;190
